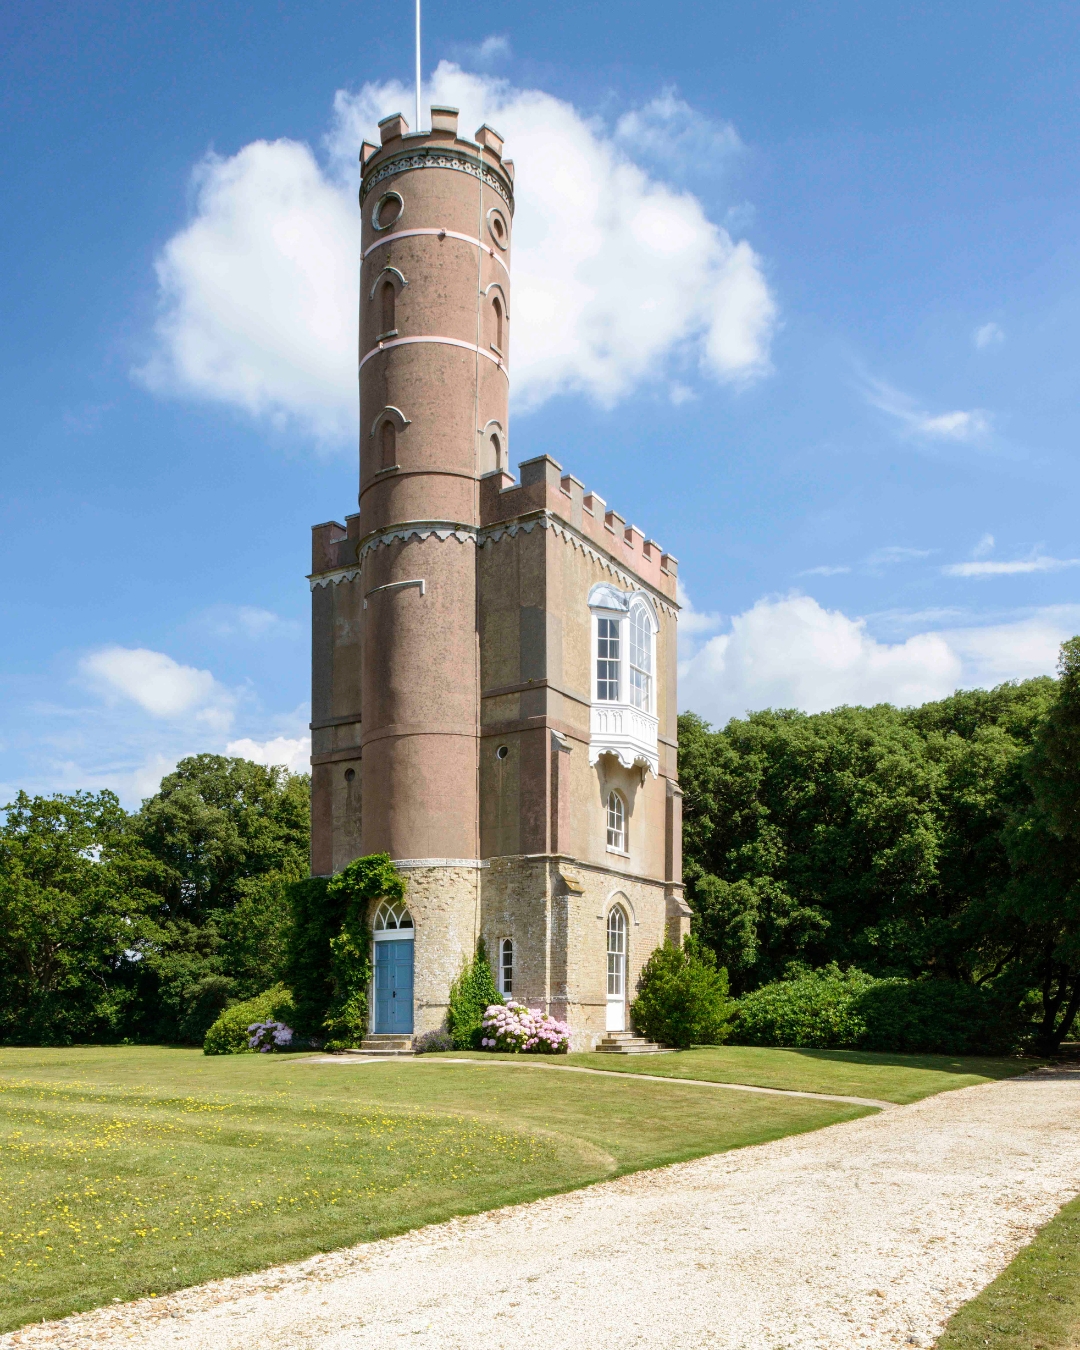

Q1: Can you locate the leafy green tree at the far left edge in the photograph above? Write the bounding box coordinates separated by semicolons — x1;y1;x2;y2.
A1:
0;791;159;1045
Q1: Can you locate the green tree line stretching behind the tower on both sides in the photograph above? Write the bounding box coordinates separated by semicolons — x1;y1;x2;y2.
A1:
0;637;1080;1050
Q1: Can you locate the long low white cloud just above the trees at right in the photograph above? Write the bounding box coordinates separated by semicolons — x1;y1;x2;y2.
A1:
679;595;1080;724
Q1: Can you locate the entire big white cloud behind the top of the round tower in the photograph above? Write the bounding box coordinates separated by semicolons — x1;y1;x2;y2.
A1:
138;62;776;441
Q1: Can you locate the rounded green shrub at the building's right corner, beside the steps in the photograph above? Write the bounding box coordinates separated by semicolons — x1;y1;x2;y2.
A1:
630;938;734;1050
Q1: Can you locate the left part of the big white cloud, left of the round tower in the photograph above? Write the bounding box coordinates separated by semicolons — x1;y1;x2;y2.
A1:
136;140;360;441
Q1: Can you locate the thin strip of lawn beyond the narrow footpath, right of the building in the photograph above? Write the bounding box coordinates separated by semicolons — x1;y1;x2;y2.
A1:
434;1045;1046;1106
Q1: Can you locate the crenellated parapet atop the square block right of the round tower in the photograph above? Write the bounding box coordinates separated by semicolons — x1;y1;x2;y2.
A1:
481;455;679;599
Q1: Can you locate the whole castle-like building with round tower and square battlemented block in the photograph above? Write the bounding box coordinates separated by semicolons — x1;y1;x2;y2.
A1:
311;108;687;1044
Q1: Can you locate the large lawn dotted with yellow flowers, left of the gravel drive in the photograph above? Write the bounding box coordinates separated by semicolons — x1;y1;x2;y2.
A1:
0;1046;867;1331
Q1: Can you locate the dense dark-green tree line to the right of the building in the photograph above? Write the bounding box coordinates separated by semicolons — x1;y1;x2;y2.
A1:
679;637;1080;1050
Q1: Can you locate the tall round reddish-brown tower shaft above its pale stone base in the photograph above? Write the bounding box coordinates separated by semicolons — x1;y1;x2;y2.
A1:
359;108;513;858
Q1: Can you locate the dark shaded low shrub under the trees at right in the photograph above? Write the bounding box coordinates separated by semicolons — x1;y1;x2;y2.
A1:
859;980;1019;1054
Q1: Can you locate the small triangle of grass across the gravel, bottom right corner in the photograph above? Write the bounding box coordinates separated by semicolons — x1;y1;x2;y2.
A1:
937;1199;1080;1350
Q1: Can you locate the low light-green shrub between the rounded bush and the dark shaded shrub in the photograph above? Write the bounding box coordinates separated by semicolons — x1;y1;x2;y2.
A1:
732;965;878;1050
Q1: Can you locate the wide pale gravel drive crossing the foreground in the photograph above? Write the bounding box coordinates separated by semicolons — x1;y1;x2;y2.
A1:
0;1071;1080;1350
